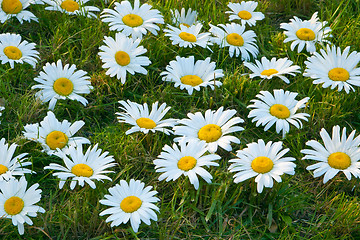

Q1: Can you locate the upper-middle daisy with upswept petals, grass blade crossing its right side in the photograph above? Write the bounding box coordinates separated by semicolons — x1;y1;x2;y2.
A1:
160;56;224;95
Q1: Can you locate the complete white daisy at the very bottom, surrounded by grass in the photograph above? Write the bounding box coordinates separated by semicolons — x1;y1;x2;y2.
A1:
99;179;160;232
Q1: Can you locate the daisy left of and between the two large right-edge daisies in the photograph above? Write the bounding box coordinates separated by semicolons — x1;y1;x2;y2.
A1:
248;89;310;138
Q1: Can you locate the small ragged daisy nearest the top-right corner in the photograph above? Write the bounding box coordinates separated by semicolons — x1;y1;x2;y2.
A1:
280;12;331;53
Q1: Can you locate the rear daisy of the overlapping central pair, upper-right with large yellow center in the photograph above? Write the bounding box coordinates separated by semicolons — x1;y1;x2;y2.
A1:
174;107;244;153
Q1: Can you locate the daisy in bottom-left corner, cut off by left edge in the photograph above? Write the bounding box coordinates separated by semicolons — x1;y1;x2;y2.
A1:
0;177;45;235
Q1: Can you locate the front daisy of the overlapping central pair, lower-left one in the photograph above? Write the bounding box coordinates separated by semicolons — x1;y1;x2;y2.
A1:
154;140;221;190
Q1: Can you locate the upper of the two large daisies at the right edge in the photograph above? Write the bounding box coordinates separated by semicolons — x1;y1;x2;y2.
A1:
304;45;360;93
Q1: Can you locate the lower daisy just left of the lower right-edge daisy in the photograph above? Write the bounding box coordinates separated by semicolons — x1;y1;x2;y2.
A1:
229;139;296;193
